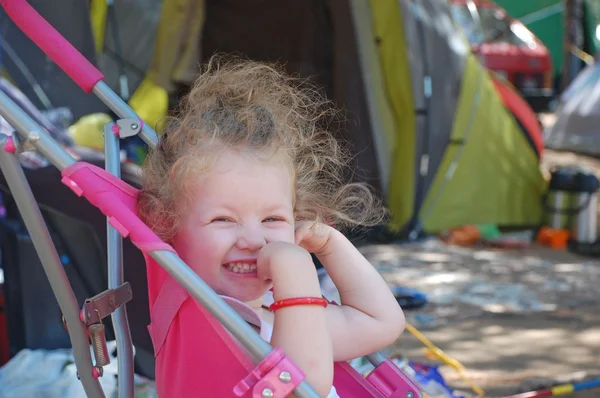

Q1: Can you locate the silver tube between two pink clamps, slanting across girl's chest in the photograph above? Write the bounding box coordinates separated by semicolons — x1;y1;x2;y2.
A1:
149;251;319;398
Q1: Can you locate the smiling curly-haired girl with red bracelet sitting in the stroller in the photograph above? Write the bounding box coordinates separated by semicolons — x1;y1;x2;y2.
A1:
138;58;404;397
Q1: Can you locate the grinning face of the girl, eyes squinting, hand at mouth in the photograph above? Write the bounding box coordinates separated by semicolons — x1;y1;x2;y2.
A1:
173;151;294;301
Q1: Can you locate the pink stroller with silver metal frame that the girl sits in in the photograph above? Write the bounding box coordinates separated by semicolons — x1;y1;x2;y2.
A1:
0;0;421;398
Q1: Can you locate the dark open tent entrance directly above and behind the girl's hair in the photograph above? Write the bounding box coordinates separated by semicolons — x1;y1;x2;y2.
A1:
200;0;382;199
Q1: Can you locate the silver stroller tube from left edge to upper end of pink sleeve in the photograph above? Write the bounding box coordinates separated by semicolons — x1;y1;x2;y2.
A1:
0;90;75;170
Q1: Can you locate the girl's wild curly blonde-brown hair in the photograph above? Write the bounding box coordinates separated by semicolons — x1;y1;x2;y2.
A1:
138;56;385;241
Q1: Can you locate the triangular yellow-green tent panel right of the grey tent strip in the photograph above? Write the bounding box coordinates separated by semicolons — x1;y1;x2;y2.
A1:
421;54;545;231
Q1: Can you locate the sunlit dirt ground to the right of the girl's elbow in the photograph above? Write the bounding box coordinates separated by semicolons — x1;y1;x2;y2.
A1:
362;139;600;398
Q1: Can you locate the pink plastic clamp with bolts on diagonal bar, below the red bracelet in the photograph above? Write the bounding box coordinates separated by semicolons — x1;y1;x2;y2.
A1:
233;348;305;398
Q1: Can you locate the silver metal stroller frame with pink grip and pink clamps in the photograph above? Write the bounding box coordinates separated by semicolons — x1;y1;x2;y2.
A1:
0;0;420;398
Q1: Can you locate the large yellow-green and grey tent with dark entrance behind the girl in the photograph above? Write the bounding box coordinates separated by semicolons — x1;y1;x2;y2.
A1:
2;0;545;236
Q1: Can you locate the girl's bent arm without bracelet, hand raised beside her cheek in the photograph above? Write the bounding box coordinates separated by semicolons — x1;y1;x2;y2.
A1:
296;224;405;361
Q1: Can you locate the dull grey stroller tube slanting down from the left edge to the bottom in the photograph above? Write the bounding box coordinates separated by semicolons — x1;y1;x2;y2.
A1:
0;141;104;398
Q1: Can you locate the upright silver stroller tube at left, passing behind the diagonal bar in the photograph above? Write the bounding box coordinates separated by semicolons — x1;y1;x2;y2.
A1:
104;123;134;398
